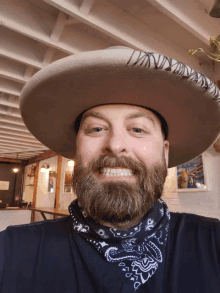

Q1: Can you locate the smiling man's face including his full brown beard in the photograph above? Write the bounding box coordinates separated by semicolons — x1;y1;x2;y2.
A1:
73;104;169;228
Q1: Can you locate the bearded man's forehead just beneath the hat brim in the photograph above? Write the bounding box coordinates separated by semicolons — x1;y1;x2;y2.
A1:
82;104;160;126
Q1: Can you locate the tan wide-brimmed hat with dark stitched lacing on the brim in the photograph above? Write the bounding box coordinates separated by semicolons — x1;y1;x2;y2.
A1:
20;47;220;168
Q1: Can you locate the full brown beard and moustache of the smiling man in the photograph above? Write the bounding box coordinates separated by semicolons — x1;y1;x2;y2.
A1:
72;149;167;229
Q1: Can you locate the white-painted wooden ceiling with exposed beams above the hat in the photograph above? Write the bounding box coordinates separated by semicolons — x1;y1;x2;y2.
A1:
0;0;220;160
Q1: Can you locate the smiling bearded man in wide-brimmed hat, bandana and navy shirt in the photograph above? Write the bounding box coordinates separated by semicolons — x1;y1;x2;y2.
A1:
0;47;220;293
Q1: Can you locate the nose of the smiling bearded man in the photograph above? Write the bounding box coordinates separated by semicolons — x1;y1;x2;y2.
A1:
103;133;129;156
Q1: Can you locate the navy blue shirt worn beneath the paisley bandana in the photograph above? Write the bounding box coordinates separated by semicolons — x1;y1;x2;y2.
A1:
0;212;220;293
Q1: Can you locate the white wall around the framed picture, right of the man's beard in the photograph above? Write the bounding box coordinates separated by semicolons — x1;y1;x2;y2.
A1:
162;147;220;219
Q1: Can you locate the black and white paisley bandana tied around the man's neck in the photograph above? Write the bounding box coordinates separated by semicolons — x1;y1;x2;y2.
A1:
69;199;170;291
